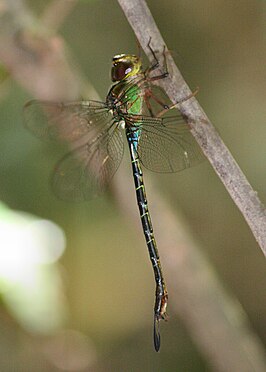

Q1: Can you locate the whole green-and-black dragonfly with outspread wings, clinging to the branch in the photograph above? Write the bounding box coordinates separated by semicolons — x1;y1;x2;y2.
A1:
24;42;203;351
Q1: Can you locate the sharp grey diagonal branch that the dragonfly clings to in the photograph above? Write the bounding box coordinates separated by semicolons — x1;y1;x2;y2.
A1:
118;0;266;256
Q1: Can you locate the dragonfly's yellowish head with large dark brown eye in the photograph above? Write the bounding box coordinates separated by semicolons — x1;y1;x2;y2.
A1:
111;54;142;82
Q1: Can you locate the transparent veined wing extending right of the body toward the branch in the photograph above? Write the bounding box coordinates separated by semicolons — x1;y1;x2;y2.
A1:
132;115;204;173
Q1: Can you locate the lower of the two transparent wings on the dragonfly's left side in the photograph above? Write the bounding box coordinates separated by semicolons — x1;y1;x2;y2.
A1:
52;128;124;201
